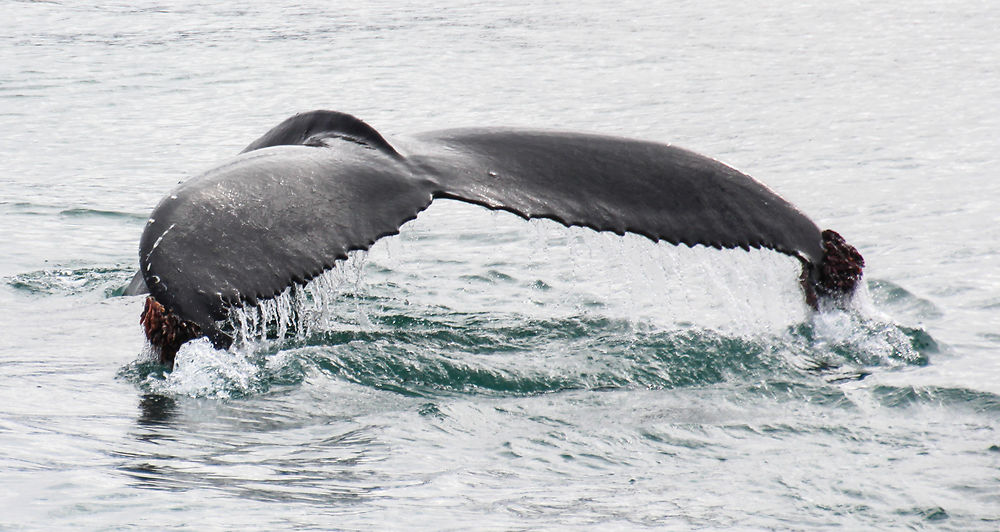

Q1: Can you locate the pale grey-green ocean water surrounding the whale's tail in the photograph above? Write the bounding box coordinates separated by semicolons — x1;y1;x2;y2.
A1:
0;0;1000;530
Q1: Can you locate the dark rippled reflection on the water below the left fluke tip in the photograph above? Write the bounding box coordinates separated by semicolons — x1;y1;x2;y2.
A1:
117;394;390;504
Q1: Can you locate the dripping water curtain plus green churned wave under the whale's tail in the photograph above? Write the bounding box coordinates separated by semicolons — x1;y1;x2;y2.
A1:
123;206;937;397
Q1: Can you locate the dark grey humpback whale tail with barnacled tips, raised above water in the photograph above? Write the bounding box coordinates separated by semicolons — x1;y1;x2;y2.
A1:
127;110;864;366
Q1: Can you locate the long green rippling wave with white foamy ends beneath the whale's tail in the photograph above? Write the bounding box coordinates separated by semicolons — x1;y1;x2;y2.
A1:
120;298;940;398
